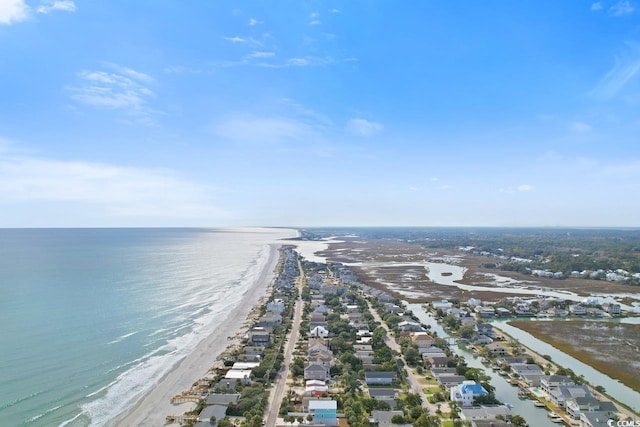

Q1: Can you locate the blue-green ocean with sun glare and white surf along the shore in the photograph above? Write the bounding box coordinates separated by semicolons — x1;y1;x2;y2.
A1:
0;229;296;426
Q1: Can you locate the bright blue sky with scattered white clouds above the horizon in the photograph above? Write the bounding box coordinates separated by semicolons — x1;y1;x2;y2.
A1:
0;0;640;227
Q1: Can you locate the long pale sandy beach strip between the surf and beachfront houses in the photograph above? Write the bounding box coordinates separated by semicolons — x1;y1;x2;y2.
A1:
108;244;281;426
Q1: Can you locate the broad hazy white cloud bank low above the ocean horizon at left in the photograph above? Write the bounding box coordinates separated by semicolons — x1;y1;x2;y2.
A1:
0;153;222;219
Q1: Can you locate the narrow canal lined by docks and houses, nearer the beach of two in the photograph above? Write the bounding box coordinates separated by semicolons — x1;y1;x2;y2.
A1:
406;304;557;427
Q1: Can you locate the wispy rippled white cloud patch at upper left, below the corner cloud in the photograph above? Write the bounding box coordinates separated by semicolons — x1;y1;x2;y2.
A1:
69;64;154;120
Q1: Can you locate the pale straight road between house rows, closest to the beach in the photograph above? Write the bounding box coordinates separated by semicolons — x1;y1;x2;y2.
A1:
265;261;304;427
